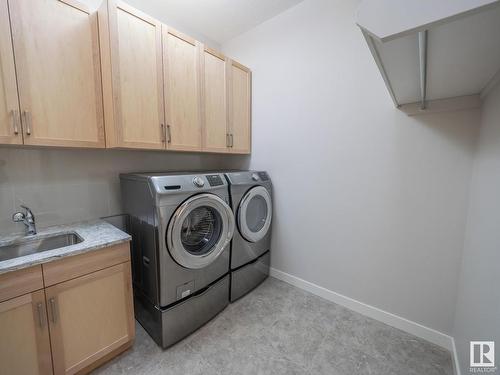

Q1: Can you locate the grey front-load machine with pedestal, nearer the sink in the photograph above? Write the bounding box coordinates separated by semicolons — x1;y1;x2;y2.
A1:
120;172;235;348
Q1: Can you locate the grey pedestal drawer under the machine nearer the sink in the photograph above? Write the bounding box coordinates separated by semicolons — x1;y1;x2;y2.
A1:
134;275;229;349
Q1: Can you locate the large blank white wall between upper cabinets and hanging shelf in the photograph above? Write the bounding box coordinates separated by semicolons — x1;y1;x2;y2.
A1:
222;0;480;333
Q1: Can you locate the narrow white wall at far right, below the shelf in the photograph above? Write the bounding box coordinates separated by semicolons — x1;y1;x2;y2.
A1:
453;85;500;374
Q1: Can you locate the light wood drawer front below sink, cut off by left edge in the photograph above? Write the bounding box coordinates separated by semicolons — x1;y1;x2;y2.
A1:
0;266;43;302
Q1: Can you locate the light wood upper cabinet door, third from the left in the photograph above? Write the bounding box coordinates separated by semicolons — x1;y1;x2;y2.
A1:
99;0;165;149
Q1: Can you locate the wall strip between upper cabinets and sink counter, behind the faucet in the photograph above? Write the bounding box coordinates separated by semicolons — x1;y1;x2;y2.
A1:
0;147;247;235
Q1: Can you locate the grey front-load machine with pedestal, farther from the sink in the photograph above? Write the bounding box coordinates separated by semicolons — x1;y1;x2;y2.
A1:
225;171;273;301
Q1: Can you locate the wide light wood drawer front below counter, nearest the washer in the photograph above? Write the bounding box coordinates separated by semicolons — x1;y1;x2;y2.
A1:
42;242;130;287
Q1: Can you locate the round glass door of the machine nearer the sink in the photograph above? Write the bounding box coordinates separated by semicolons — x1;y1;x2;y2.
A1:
166;194;234;269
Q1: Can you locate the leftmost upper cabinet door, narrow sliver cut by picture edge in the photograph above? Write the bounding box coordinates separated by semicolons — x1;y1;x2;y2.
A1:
0;0;23;144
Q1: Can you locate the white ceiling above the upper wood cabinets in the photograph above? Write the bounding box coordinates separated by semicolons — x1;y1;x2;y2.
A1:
81;0;302;45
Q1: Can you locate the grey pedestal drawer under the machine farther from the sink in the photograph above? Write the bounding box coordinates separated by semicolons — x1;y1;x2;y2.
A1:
231;251;271;302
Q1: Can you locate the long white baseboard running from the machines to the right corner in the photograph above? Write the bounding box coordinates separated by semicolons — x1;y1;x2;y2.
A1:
270;267;460;352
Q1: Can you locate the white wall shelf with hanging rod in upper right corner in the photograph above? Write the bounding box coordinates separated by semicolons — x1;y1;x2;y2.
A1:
357;0;500;115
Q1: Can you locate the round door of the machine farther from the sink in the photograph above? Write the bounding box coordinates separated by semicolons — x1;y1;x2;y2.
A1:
238;186;273;242
